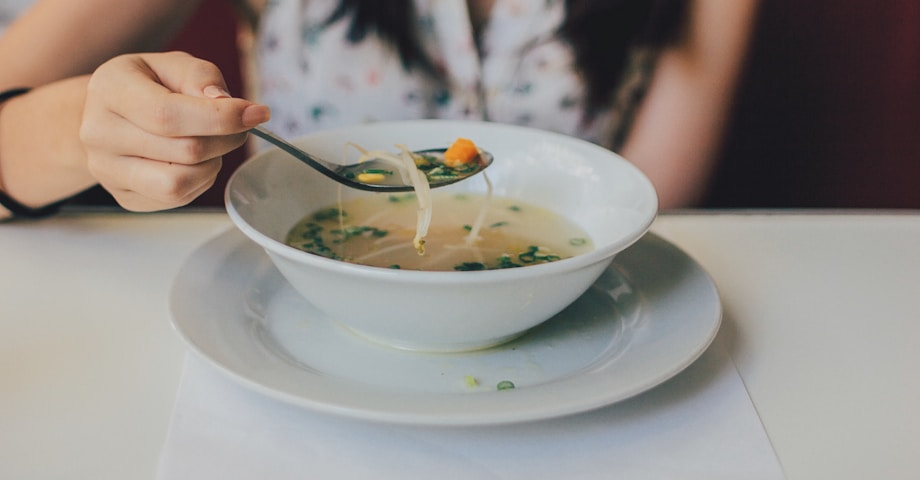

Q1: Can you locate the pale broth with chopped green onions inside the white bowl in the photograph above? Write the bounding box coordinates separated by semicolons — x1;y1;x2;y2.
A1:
287;192;594;271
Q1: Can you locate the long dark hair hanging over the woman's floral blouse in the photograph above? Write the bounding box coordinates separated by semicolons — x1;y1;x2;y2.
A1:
326;0;687;109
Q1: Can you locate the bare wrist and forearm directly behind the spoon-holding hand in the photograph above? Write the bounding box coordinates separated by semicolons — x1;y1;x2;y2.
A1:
0;77;96;217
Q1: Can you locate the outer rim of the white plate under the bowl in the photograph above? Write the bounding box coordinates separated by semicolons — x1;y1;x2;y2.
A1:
169;226;722;426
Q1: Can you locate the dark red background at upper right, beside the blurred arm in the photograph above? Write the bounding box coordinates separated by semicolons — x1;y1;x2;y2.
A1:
708;0;920;208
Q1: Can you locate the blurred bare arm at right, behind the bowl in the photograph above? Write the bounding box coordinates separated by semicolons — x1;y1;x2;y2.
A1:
622;0;757;209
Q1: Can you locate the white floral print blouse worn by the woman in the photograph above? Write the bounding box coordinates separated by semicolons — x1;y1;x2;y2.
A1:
256;0;651;149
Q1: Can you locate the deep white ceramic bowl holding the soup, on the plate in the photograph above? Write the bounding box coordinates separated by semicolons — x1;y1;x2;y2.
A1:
226;120;658;351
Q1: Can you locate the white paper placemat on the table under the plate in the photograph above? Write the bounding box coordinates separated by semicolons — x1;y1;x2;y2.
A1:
158;334;783;480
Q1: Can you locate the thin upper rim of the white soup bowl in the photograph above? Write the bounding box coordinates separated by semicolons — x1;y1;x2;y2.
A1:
224;119;658;284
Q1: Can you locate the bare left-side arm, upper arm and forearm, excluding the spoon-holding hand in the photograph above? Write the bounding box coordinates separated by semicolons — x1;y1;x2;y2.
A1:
0;0;210;219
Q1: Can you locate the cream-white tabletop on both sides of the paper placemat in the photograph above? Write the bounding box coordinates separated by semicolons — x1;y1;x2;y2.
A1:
0;211;920;480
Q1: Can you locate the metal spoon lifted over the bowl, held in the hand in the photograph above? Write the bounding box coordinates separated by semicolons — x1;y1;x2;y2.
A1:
249;127;493;192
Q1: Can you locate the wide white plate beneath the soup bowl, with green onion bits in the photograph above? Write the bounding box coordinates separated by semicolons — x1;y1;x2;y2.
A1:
170;229;721;425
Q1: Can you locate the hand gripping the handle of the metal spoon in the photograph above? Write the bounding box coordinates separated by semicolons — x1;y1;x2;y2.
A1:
80;52;270;211
